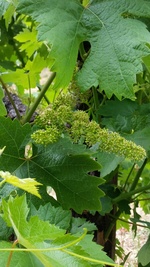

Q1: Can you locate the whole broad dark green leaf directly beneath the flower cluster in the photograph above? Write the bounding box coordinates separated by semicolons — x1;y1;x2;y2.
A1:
0;118;103;213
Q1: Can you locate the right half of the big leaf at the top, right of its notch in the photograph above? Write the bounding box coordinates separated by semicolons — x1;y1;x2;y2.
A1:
78;0;150;99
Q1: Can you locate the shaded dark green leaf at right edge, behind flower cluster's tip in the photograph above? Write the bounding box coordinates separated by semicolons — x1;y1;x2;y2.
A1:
99;99;150;153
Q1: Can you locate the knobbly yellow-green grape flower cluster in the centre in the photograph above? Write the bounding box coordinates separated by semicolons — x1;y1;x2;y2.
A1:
32;93;146;161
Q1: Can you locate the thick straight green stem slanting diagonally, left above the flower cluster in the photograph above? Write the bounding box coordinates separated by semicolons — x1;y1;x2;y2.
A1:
21;72;56;124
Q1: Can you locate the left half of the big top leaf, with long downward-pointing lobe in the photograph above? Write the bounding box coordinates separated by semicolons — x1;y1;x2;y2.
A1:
18;0;84;90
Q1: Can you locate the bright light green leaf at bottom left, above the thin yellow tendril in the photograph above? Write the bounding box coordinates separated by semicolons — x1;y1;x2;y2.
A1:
2;195;65;244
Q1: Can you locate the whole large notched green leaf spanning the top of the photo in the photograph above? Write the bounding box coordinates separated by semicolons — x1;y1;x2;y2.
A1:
17;0;150;99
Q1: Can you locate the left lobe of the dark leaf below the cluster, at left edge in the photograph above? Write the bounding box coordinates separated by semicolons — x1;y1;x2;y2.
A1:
0;117;31;173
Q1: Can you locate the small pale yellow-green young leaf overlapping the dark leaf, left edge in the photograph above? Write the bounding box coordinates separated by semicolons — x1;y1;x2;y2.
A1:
0;171;42;198
